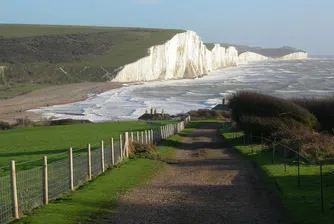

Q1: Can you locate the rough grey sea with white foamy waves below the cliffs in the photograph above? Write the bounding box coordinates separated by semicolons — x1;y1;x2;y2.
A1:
31;58;334;122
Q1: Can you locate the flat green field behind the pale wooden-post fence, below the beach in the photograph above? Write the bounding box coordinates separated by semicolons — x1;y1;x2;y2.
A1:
0;121;175;176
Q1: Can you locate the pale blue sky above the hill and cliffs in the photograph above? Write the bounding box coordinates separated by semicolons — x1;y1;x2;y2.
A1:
0;0;334;55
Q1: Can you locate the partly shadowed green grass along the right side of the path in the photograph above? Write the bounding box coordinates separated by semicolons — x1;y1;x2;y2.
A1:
223;129;334;224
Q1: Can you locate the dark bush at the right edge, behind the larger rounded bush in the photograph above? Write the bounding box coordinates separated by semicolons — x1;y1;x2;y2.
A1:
292;97;334;134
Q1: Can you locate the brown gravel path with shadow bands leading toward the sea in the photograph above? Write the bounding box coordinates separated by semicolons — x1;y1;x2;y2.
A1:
94;124;286;224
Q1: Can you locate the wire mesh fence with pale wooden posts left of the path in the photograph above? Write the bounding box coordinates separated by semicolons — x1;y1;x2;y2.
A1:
0;117;190;224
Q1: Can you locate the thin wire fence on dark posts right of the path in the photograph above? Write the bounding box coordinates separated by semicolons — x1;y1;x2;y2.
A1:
224;123;334;218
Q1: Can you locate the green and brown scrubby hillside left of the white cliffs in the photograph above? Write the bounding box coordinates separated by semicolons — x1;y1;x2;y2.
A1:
0;24;184;99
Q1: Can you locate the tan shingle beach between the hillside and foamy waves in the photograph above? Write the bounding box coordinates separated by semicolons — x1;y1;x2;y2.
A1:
0;82;124;123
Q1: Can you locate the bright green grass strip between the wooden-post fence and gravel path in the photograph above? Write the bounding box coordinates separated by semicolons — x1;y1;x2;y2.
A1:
16;129;185;224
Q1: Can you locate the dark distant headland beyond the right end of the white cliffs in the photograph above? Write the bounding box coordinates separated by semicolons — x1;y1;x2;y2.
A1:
205;43;305;58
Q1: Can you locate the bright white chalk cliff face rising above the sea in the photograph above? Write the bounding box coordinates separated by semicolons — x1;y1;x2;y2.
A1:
112;31;307;82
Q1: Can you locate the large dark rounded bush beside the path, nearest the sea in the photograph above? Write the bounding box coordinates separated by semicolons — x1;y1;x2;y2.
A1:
229;91;318;128
